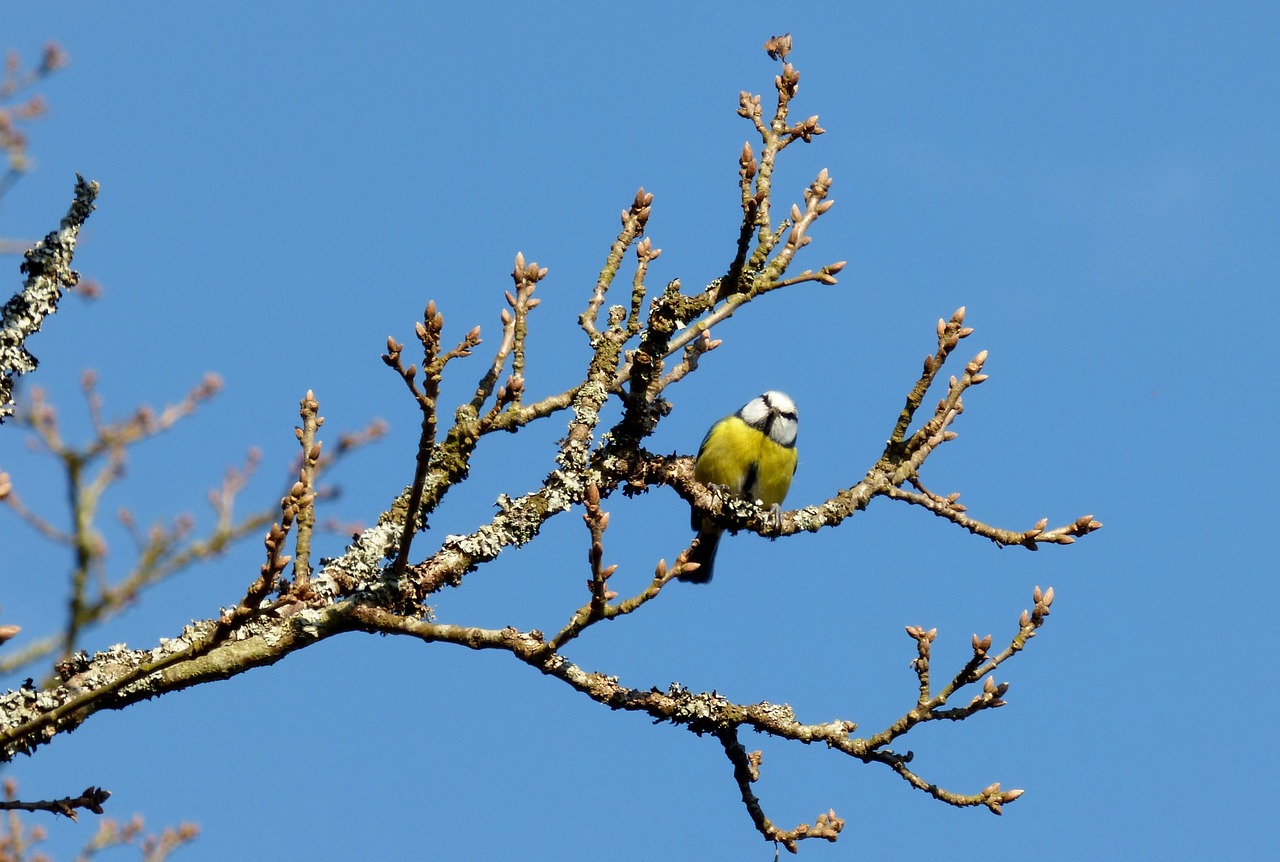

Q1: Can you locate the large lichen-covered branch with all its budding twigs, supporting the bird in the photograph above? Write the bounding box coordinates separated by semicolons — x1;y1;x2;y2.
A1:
0;37;1101;852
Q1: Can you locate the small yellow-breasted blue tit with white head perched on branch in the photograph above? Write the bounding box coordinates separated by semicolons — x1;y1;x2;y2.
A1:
680;392;799;584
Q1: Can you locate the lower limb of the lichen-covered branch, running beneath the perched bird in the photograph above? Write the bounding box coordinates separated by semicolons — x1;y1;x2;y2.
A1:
0;569;1053;845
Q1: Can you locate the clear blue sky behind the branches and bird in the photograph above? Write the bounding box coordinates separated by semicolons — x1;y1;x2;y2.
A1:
0;3;1280;859
